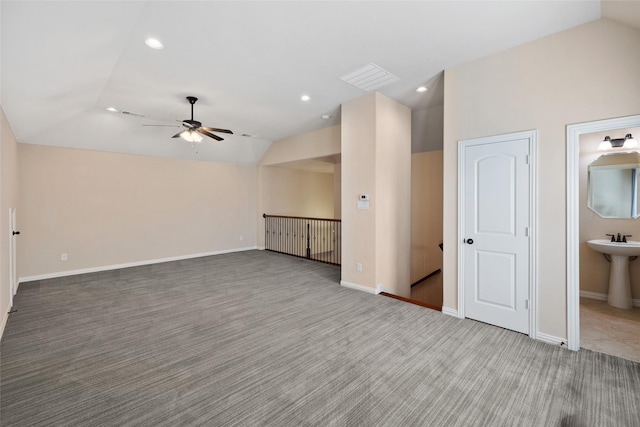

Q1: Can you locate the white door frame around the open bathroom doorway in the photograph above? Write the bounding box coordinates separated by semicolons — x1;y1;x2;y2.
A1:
567;115;640;351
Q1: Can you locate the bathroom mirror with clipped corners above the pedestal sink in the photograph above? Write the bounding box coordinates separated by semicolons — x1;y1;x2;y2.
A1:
587;152;640;218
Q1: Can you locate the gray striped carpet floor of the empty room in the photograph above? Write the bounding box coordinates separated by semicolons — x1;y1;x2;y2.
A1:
0;251;640;426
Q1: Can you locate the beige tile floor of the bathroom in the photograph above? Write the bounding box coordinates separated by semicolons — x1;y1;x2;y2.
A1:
580;298;640;362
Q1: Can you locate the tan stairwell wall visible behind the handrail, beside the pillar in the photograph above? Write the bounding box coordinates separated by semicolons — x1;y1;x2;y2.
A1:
410;150;442;283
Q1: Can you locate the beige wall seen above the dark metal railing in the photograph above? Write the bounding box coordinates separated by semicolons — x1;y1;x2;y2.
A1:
261;166;333;218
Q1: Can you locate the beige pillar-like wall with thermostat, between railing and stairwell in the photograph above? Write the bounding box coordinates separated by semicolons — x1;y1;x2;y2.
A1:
342;93;411;297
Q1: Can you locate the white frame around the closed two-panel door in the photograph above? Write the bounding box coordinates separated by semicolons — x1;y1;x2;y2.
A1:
458;130;538;339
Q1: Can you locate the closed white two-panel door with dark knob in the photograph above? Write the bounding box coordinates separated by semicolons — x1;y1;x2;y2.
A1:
460;134;532;334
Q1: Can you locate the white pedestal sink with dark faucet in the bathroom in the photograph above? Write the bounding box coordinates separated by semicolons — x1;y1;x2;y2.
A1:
587;239;640;308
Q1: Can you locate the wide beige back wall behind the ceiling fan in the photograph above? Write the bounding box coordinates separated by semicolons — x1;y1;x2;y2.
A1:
18;144;256;278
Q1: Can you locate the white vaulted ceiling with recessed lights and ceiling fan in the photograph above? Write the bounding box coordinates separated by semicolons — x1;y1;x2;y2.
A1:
0;0;600;164
